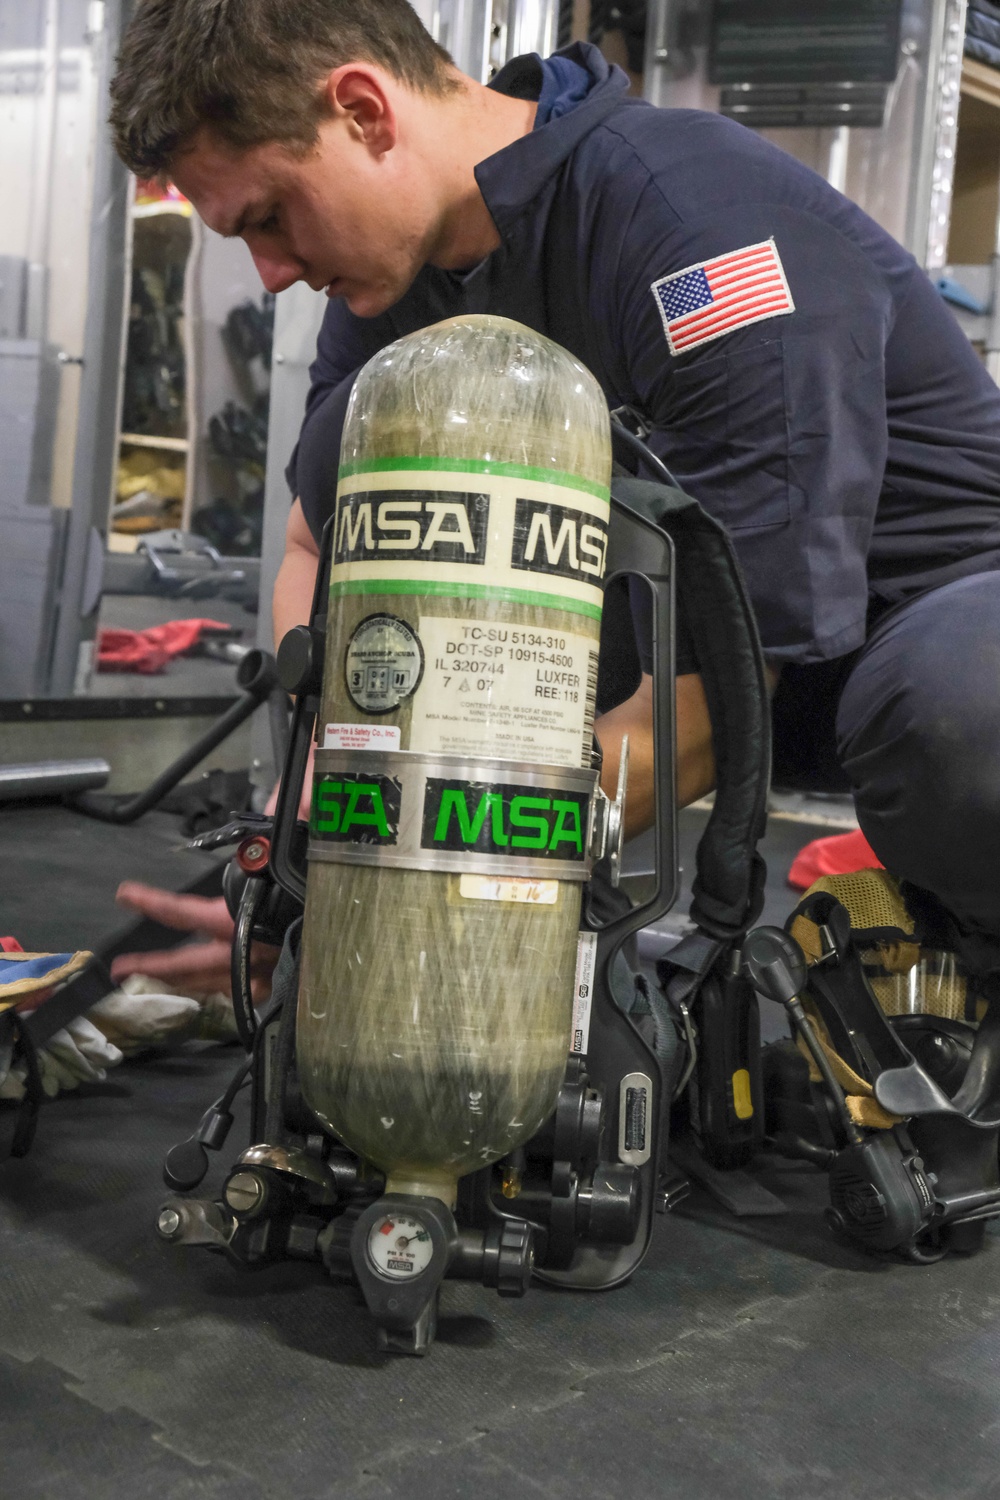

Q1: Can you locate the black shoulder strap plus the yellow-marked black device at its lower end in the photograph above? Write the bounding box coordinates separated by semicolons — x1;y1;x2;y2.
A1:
612;459;771;1170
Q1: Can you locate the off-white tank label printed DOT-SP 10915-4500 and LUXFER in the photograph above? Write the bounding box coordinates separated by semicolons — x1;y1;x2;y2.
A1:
409;615;598;767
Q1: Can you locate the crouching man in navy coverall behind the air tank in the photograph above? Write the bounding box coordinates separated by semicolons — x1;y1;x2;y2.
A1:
112;0;1000;984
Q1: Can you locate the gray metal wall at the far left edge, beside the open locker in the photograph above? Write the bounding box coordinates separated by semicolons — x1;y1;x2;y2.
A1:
0;0;127;699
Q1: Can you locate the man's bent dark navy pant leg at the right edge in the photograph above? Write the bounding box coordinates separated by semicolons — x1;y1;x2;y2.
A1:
837;573;1000;963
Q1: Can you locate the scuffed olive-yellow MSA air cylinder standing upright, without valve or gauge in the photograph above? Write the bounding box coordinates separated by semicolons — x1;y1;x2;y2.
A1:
297;317;610;1202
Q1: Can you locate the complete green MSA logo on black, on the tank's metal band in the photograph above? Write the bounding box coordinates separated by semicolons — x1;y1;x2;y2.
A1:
420;777;589;864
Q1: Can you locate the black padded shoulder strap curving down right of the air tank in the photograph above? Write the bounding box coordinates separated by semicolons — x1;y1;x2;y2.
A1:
612;479;771;942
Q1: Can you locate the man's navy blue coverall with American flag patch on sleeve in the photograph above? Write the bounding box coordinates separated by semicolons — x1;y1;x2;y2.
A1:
289;44;1000;968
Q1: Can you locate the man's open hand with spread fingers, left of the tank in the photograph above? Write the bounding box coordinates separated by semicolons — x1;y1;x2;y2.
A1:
111;881;279;1002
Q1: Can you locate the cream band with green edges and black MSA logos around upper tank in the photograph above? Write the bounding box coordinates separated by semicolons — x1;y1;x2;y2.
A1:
330;461;610;620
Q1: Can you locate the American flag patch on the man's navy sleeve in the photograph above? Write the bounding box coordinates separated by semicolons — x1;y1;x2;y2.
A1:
651;240;795;354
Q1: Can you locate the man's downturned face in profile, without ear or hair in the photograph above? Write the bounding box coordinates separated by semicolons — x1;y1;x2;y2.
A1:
172;119;433;318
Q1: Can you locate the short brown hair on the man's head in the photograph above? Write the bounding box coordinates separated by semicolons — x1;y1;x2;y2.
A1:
111;0;456;177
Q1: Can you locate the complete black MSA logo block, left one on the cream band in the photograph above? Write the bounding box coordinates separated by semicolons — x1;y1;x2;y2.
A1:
334;489;490;563
